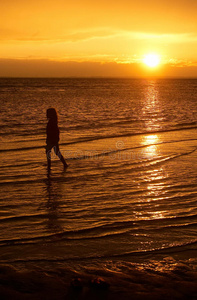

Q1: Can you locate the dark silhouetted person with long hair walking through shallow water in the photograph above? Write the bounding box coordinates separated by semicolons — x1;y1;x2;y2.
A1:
46;108;68;171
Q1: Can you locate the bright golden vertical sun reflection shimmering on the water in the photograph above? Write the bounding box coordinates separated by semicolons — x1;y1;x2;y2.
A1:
141;90;168;220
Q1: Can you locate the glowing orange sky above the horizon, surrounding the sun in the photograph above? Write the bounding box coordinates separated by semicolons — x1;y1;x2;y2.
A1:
0;0;197;78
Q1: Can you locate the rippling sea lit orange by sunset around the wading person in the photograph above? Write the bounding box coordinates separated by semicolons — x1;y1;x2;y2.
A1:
0;78;197;299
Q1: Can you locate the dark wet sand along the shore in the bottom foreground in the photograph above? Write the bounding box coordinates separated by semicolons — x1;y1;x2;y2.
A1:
0;264;197;300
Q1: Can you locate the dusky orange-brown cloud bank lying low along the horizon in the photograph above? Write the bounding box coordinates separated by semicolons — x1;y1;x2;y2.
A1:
0;59;197;78
